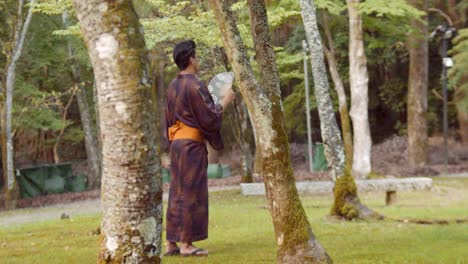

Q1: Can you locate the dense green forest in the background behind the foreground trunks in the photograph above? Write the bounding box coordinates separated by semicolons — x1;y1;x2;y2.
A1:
0;0;468;191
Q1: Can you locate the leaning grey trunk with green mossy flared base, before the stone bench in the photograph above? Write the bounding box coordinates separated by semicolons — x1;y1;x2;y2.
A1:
300;0;378;219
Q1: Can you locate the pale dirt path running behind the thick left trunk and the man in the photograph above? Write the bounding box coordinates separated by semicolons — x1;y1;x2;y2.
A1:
0;186;240;228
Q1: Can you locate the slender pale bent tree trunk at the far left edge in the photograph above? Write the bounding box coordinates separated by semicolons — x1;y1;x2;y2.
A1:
3;0;36;208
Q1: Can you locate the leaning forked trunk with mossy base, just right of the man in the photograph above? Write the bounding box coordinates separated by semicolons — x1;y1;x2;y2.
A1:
210;0;331;263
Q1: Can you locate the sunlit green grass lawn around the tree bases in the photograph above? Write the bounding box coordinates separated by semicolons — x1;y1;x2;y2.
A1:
0;179;468;264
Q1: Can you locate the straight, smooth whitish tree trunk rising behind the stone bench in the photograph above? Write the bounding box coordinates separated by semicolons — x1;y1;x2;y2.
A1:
346;0;372;178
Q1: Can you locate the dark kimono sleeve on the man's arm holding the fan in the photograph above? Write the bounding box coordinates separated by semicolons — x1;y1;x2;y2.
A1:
187;81;224;150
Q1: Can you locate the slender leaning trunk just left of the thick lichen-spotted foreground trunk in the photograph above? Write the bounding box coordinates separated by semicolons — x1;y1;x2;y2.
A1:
62;12;101;189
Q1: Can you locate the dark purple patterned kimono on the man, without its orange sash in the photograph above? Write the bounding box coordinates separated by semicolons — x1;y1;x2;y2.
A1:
165;74;223;242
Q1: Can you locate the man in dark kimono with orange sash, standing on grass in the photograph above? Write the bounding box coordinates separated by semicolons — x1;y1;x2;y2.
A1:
164;40;235;256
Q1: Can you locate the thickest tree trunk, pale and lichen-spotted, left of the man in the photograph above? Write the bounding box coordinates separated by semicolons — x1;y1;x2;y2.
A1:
74;0;162;263
